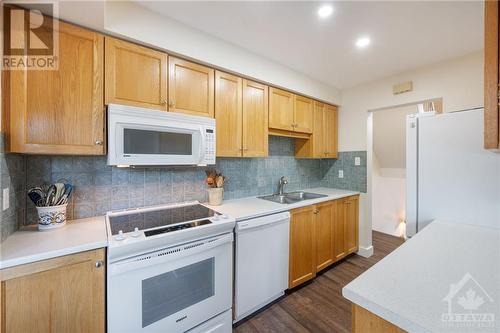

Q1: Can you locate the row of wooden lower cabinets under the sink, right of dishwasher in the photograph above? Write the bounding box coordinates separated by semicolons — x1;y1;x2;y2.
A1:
288;195;359;288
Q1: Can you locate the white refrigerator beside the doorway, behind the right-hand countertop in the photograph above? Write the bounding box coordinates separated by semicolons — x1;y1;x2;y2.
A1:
406;108;500;237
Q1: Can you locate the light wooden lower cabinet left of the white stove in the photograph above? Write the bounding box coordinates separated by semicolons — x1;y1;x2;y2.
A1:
0;249;106;333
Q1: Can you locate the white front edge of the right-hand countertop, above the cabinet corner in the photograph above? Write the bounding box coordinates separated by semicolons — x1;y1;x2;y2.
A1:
342;287;432;333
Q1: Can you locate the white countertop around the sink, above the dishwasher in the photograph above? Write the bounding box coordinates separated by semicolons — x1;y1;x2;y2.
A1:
207;187;359;221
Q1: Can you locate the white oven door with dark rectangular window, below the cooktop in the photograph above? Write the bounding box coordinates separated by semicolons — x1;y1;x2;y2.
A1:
107;234;233;332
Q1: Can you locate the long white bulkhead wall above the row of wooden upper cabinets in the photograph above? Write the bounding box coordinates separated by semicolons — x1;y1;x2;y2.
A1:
104;1;340;104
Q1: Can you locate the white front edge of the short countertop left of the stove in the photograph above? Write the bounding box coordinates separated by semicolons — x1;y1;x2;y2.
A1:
0;240;108;269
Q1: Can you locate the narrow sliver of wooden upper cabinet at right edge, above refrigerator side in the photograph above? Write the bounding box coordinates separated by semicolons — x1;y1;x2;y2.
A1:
484;1;500;149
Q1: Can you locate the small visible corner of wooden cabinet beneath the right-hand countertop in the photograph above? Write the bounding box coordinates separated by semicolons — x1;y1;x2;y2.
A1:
352;304;406;333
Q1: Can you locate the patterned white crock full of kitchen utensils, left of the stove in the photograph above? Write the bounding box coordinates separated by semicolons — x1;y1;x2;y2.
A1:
28;181;73;230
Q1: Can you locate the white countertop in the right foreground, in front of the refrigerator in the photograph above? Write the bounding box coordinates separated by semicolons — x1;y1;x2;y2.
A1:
342;221;500;332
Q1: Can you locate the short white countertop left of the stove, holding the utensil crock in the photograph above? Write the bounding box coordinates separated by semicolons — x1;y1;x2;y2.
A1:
0;216;108;269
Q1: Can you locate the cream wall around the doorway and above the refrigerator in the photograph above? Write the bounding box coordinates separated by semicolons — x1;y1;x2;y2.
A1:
339;51;483;151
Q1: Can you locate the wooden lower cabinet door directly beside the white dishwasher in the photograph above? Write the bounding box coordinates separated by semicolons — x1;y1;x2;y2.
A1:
288;206;316;288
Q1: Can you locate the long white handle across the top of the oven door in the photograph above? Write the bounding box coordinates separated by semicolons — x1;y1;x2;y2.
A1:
108;233;233;276
